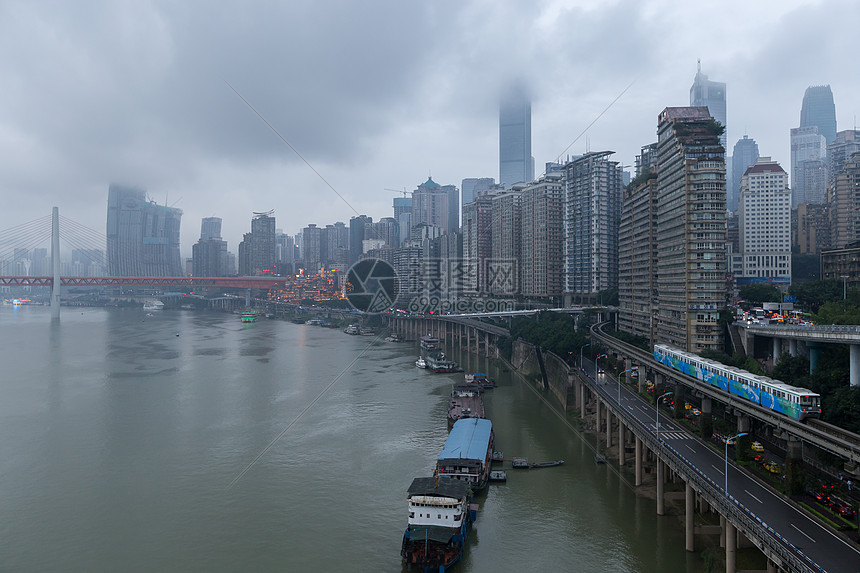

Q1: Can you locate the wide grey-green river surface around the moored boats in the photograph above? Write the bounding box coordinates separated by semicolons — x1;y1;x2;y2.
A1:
0;306;701;572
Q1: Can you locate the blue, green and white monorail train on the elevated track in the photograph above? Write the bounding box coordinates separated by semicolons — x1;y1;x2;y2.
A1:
654;344;821;420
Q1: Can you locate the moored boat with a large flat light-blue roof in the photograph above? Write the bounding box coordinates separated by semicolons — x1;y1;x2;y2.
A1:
436;418;494;491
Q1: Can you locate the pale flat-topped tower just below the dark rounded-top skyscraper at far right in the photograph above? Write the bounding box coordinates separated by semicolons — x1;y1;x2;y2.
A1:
791;125;827;207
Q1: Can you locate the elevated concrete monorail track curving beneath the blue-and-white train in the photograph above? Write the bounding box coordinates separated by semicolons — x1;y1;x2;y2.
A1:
591;322;860;465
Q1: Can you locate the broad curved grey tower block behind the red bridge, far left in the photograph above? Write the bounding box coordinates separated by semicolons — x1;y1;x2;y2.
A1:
107;184;185;277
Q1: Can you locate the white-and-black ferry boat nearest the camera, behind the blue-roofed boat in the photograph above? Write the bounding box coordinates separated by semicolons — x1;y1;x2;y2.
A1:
400;477;477;573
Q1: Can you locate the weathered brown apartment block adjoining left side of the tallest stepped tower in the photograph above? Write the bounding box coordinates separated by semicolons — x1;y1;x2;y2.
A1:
618;172;657;345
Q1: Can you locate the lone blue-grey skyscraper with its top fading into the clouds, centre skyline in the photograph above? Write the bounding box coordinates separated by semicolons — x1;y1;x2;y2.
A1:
499;88;535;189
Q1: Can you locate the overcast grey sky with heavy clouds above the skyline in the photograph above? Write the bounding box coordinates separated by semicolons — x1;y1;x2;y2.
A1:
0;0;860;256
